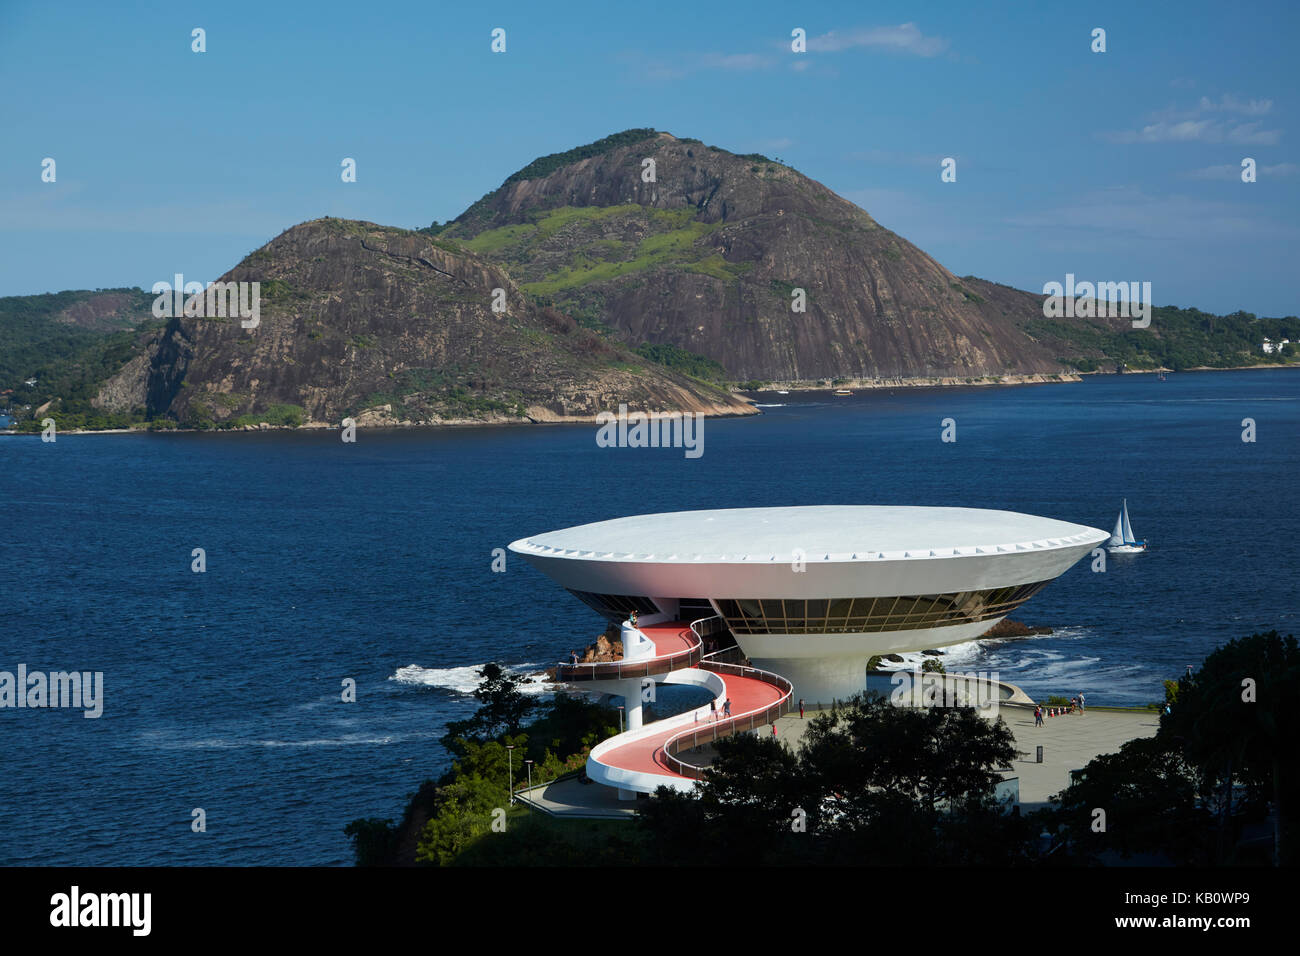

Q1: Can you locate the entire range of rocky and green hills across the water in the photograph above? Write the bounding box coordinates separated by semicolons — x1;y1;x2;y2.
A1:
0;129;1300;431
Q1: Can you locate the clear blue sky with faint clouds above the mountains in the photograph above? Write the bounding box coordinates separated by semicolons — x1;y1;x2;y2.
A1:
0;0;1300;315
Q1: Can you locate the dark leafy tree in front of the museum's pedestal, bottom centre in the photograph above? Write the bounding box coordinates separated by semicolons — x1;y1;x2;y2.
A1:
638;695;1032;865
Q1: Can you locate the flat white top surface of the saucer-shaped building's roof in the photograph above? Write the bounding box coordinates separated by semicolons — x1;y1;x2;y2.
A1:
511;505;1110;563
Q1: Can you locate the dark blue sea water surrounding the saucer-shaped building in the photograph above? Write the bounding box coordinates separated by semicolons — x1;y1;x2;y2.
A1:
0;369;1300;865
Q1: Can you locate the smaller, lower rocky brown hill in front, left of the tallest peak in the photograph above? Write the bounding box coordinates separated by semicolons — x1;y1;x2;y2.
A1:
96;220;753;427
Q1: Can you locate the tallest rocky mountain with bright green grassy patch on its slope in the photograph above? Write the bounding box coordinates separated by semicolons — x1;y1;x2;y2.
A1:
441;130;1081;381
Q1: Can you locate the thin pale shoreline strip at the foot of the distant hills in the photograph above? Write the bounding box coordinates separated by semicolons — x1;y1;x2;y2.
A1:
0;363;1300;438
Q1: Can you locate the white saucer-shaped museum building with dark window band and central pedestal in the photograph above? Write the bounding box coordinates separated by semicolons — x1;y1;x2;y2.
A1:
510;506;1109;701
